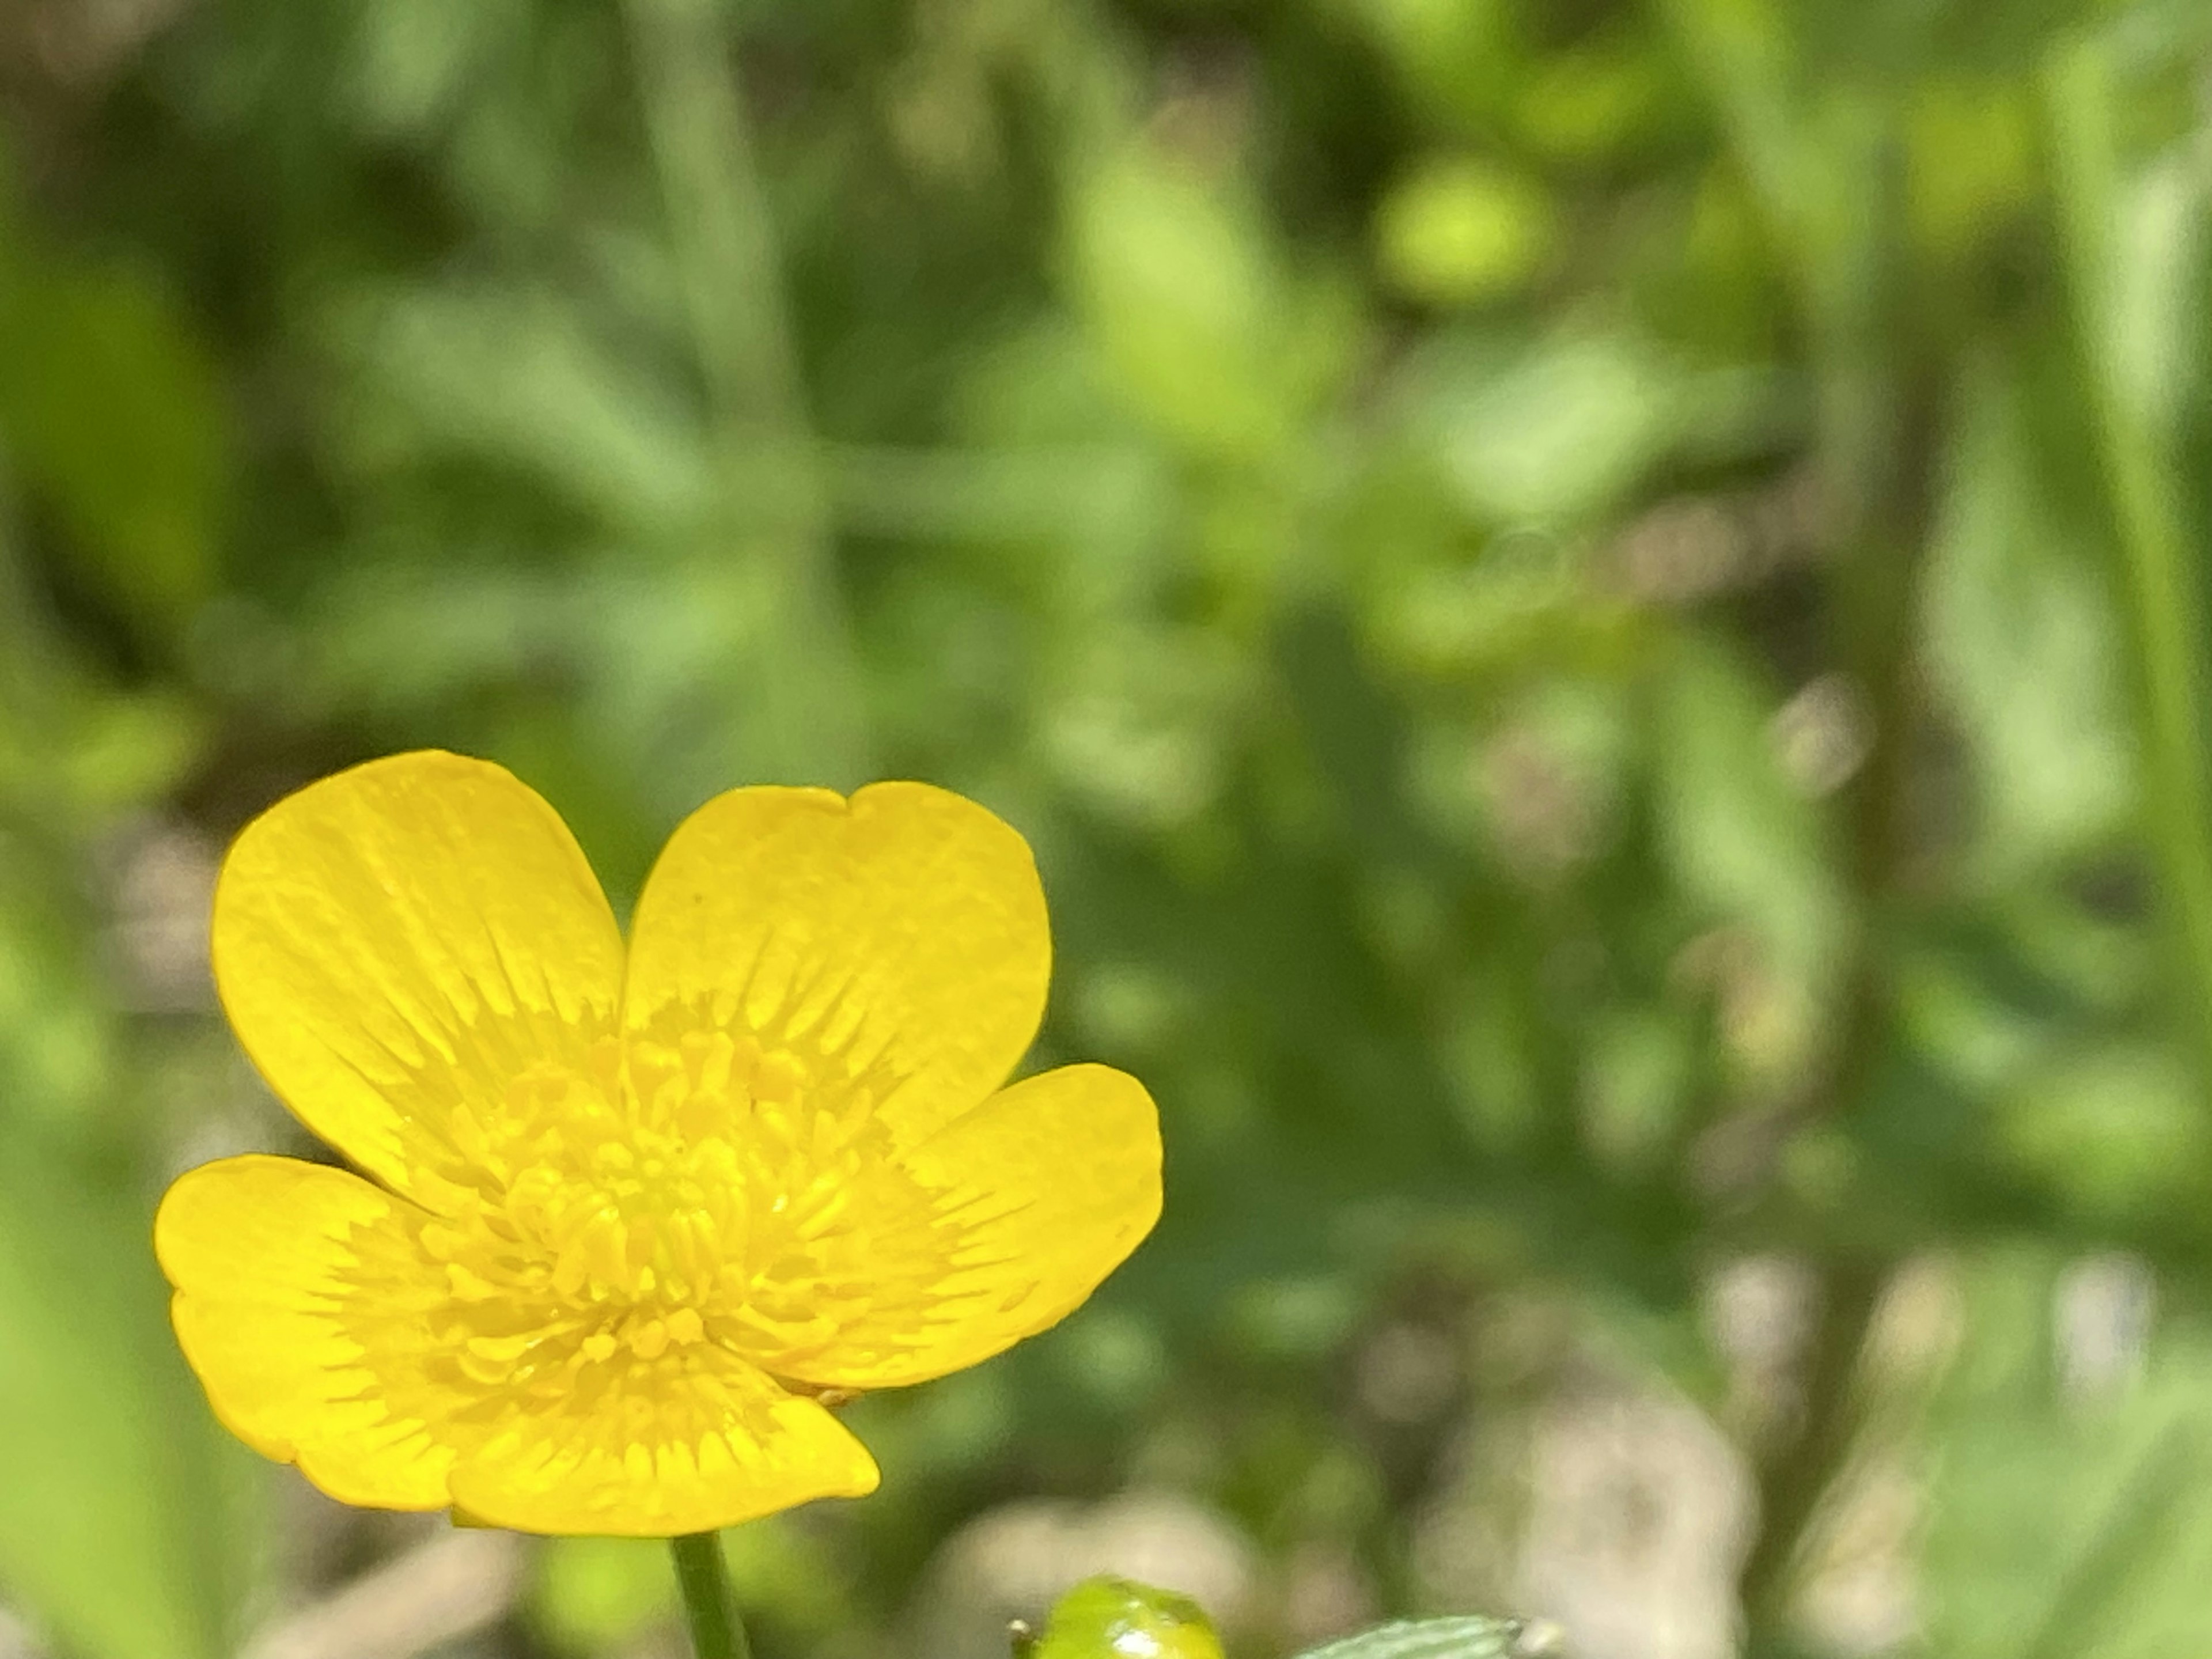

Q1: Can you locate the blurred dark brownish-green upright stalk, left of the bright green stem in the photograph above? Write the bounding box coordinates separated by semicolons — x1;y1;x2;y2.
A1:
1664;0;1938;1654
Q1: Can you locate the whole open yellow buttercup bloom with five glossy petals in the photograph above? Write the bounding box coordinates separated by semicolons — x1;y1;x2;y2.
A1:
155;754;1159;1535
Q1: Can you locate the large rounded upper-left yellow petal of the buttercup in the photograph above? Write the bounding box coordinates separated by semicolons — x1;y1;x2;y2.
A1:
213;752;622;1203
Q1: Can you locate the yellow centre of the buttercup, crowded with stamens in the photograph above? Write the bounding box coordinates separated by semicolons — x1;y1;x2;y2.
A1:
369;1031;927;1404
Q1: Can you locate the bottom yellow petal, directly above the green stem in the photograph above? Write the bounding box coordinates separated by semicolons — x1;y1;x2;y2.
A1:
451;1347;878;1537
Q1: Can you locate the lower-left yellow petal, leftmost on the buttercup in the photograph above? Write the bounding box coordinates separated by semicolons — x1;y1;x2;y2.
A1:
155;1157;451;1509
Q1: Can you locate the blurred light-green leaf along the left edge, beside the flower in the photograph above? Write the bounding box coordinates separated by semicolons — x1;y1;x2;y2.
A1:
0;606;248;1659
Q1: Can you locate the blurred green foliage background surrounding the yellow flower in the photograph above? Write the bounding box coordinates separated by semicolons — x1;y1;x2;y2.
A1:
0;0;2212;1659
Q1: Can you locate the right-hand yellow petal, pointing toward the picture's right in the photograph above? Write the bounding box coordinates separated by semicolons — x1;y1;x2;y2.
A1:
761;1066;1159;1389
